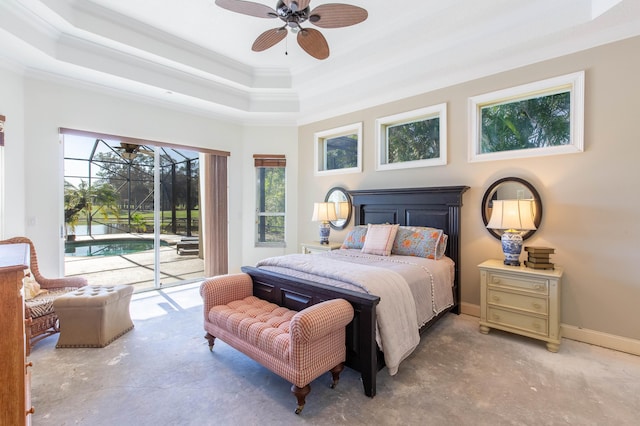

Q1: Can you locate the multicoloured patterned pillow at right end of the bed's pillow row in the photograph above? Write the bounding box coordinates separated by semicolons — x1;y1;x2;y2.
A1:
391;226;448;259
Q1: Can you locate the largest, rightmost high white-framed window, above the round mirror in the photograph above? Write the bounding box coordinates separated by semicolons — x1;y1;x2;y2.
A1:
469;72;584;161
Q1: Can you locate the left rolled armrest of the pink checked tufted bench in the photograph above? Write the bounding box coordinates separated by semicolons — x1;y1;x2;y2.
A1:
200;273;253;320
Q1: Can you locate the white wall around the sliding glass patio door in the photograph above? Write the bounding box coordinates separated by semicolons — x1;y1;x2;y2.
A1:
0;71;297;276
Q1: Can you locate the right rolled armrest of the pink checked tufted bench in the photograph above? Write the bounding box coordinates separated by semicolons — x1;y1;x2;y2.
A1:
289;299;353;343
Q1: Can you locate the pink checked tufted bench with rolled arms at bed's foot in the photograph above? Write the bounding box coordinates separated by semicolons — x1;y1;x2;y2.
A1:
200;273;353;414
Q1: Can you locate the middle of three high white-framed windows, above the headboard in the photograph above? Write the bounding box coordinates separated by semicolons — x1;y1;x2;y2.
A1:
376;104;447;170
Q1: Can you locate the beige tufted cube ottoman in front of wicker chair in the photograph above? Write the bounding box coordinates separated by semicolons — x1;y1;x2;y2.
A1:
53;285;133;348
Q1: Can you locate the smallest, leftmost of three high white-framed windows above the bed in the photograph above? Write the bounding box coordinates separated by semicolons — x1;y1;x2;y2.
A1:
314;123;362;175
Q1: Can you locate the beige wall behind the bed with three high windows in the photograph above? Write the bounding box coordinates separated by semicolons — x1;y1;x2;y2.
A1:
298;38;640;339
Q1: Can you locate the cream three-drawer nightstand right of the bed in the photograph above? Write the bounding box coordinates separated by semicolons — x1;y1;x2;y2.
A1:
478;259;563;352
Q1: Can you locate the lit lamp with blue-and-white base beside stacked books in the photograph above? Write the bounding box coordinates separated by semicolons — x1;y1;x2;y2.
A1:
487;200;536;266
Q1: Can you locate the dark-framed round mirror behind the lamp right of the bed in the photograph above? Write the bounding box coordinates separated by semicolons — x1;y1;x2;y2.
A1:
481;177;542;240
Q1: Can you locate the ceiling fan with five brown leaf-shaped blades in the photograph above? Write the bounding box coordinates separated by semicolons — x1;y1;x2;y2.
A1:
216;0;369;59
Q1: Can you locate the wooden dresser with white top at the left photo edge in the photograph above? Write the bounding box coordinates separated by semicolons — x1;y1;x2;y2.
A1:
0;244;33;425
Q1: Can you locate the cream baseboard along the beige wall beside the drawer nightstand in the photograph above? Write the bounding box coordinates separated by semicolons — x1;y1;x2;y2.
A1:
460;302;640;356
